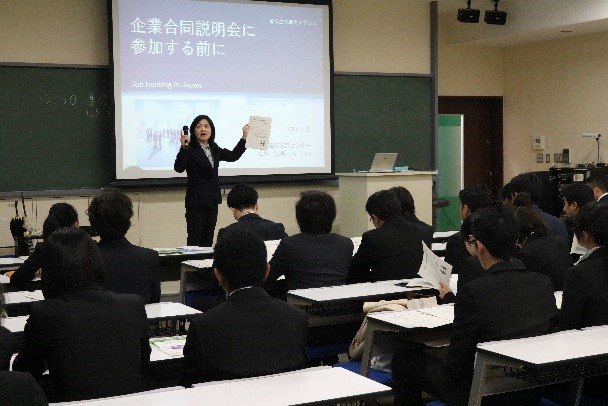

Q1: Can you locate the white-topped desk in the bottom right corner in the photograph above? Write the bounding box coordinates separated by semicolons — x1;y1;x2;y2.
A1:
469;326;608;406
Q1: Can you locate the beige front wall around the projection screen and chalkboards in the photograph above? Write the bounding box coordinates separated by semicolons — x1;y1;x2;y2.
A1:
0;0;430;254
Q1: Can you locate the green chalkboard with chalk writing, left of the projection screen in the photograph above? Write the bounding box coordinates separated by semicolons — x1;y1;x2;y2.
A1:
0;66;115;192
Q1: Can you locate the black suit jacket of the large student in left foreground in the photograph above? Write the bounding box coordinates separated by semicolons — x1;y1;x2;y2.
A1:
13;288;150;401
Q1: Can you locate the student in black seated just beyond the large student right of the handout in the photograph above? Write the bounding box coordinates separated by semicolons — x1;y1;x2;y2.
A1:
513;194;572;290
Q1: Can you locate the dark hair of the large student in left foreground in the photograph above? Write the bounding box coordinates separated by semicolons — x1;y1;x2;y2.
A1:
42;227;104;299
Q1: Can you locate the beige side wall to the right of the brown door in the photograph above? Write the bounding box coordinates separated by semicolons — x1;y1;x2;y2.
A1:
504;29;608;179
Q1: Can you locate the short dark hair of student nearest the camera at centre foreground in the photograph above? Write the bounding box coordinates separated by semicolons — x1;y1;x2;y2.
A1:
213;230;267;290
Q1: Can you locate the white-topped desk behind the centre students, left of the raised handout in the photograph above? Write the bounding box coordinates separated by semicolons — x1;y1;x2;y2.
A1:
287;279;434;326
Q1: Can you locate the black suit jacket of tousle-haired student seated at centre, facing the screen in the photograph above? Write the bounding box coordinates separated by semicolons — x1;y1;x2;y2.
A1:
268;233;353;290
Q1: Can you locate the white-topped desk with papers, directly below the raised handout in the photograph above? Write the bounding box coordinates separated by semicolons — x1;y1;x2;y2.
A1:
361;305;454;376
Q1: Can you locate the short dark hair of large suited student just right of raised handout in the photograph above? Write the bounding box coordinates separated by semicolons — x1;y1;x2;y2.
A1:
471;202;518;261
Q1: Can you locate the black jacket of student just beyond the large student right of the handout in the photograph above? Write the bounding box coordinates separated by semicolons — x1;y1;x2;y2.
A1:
515;235;572;290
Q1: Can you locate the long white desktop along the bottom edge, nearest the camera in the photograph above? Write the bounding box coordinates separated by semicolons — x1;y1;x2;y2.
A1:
55;367;391;406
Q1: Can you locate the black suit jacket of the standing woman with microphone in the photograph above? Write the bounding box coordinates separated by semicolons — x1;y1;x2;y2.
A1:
173;139;245;209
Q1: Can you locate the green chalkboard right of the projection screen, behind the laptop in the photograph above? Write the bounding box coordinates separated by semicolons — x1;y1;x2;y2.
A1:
334;75;434;173
